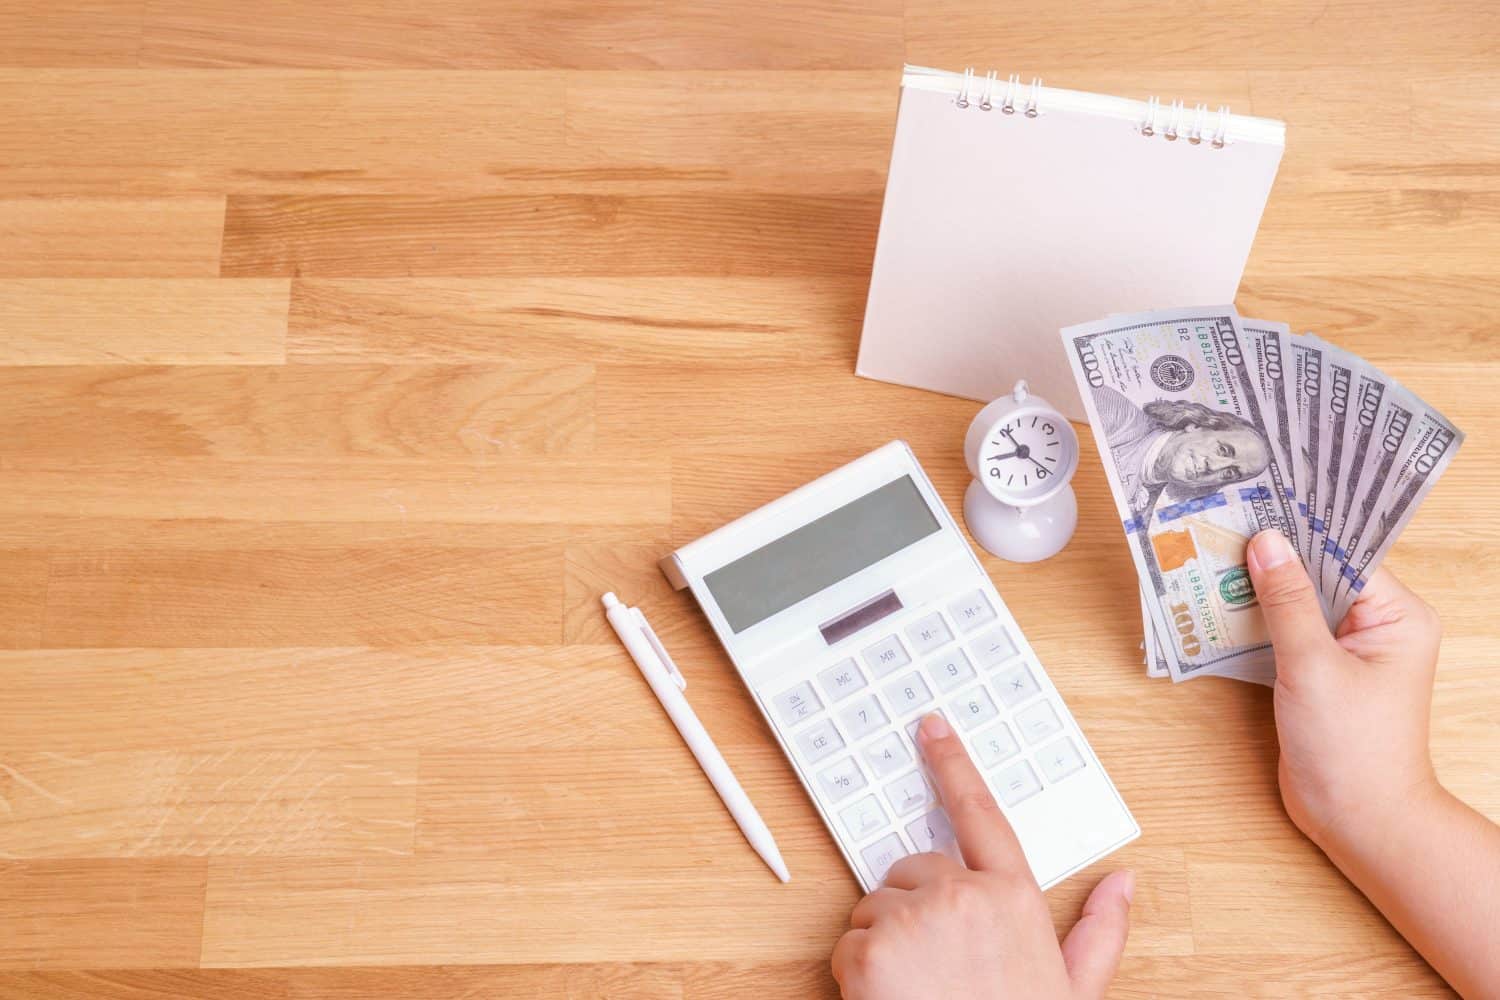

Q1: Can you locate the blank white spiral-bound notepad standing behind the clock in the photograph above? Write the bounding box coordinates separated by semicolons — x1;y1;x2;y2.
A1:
857;66;1286;420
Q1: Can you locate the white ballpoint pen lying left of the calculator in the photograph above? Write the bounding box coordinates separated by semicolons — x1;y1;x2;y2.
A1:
600;592;792;882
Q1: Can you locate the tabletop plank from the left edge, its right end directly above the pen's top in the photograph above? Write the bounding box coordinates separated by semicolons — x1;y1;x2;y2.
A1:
0;365;596;455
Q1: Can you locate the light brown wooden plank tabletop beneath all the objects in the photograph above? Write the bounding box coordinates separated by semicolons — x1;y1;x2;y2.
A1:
0;0;1500;1000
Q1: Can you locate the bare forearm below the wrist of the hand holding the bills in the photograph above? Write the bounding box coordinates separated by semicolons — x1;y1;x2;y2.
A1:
1319;784;1500;1000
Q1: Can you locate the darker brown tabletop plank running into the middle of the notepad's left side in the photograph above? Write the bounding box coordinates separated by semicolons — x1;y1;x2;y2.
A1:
222;193;881;277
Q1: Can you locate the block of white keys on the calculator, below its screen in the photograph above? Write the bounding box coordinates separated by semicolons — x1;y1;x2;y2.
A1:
764;589;1088;886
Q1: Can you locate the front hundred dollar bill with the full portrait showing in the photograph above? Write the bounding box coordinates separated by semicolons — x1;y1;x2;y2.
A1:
1062;306;1296;681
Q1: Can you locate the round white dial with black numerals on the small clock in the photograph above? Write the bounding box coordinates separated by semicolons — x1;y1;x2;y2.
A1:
978;406;1079;507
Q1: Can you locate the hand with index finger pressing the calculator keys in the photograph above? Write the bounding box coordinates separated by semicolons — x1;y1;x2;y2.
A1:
833;715;1136;1000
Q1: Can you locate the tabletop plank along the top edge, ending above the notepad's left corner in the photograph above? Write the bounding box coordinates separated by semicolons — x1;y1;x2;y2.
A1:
141;0;902;69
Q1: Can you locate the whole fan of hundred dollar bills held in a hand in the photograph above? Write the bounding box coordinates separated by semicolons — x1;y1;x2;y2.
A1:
1062;306;1464;684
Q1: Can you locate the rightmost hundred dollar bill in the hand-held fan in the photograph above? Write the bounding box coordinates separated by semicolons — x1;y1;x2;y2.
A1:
1334;402;1464;618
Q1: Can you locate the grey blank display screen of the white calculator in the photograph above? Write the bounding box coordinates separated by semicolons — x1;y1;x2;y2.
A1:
704;475;939;633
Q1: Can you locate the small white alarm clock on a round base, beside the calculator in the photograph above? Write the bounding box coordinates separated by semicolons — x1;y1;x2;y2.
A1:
963;379;1079;562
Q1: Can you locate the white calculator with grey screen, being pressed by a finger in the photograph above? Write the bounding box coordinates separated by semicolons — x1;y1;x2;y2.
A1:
662;441;1140;892
